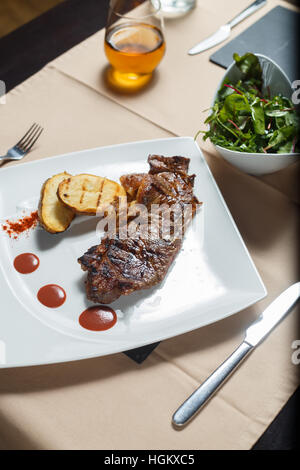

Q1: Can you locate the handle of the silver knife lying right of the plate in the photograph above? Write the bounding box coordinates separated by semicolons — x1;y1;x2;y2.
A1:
172;341;253;426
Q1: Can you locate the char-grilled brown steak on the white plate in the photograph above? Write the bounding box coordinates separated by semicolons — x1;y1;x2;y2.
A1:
78;155;199;304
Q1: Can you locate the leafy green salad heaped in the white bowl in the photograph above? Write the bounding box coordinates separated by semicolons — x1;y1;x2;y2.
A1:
195;52;300;153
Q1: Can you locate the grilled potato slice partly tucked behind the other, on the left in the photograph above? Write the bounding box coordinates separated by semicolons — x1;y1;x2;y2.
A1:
38;172;75;233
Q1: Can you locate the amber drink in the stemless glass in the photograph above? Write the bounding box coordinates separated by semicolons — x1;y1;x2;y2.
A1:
104;23;165;88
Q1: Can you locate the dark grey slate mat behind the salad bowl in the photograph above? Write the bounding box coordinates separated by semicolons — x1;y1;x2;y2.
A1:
210;6;300;81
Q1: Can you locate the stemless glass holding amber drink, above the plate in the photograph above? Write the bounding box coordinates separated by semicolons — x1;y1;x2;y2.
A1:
104;0;166;91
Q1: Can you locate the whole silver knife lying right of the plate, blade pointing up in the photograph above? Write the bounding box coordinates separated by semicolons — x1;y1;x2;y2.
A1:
172;282;300;426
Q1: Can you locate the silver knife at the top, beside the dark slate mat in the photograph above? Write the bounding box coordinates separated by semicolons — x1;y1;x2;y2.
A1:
188;0;267;55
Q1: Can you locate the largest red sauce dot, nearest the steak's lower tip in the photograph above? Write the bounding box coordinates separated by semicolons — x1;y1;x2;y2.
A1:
79;305;117;331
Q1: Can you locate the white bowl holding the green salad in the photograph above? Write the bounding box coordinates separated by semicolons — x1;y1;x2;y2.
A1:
213;54;300;175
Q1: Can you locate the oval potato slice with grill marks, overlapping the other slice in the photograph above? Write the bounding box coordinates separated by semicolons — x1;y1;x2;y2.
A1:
57;174;126;215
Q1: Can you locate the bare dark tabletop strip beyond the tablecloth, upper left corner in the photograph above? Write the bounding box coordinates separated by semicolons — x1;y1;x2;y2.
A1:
0;0;109;92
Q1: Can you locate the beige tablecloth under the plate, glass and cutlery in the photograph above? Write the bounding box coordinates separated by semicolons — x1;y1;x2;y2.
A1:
0;0;299;449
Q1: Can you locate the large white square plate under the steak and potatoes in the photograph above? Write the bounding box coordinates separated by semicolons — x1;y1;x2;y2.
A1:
0;137;266;367
